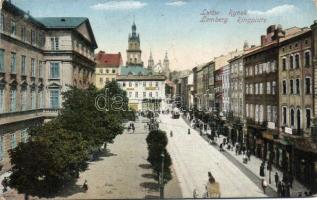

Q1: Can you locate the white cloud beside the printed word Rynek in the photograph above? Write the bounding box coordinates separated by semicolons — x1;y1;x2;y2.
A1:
248;4;296;17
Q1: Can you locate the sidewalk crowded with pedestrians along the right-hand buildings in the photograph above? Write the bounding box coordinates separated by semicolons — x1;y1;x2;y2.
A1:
183;113;312;197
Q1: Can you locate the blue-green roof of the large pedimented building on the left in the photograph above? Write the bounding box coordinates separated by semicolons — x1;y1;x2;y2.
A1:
36;17;88;28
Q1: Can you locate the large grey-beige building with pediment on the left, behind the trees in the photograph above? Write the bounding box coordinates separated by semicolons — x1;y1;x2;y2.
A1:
0;1;97;170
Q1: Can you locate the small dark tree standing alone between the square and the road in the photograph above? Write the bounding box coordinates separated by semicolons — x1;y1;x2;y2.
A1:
146;130;172;183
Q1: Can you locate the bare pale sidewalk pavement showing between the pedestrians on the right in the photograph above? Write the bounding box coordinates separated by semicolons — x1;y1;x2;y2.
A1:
183;117;309;197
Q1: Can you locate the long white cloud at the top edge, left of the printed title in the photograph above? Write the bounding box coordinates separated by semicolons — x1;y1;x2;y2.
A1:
90;1;147;10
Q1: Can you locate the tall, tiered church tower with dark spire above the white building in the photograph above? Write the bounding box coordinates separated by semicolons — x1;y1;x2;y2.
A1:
126;21;143;67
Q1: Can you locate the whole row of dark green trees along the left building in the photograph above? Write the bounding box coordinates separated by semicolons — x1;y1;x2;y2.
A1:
9;81;132;197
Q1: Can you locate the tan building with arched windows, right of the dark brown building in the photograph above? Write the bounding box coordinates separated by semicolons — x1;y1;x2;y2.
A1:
279;27;317;188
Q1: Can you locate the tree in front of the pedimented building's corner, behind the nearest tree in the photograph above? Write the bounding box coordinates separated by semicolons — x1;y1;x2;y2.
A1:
60;83;123;150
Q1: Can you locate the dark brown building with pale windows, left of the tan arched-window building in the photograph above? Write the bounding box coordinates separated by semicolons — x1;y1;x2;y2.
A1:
243;25;284;161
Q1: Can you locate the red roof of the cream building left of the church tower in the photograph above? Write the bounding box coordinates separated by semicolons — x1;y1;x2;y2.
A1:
95;51;122;68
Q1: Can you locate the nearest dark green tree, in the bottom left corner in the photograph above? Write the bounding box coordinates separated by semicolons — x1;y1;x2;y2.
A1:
9;121;88;197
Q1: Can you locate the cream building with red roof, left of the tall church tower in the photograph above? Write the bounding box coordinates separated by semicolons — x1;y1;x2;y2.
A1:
95;51;122;88
